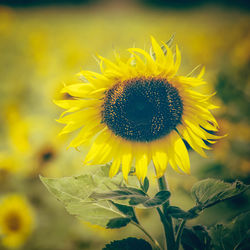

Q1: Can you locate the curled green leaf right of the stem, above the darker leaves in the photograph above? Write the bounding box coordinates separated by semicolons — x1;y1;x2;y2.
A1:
191;179;249;209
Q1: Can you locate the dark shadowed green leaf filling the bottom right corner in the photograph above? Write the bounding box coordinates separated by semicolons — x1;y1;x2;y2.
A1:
209;211;250;250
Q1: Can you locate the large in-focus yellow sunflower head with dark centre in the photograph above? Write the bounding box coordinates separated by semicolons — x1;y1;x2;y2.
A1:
55;37;219;181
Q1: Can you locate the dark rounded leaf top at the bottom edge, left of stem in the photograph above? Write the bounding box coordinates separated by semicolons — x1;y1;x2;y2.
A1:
103;237;152;250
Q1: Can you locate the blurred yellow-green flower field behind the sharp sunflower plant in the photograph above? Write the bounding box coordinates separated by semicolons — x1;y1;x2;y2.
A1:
0;0;250;250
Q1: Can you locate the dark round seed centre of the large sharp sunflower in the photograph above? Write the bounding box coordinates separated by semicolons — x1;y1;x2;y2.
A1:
102;78;183;142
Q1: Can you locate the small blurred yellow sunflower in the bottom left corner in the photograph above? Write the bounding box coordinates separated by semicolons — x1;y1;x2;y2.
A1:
0;194;34;248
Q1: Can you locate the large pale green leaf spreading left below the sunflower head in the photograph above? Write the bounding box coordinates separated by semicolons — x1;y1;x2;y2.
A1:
40;167;140;227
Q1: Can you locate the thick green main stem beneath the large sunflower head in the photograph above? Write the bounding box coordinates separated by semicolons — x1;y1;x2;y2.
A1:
158;176;175;250
